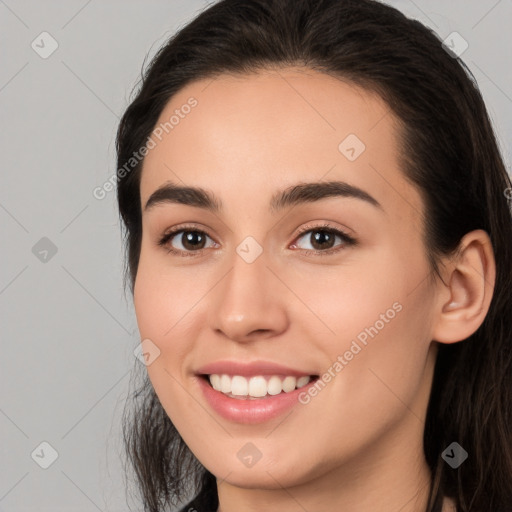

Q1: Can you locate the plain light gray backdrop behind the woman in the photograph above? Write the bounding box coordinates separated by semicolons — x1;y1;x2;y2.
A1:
0;0;512;512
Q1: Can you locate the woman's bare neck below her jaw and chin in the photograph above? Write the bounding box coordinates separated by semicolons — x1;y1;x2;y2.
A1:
217;414;431;512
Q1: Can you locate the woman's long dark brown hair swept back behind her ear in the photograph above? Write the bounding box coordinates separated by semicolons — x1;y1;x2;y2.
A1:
117;0;512;512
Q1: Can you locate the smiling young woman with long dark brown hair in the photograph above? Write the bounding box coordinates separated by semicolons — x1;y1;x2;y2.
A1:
117;0;512;512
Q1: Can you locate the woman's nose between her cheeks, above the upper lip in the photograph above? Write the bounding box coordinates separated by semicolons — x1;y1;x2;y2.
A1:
209;246;291;343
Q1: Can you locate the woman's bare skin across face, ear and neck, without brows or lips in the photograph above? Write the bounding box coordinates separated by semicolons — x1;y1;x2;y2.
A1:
134;68;495;512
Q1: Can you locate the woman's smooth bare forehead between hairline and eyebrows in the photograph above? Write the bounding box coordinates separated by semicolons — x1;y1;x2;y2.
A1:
141;68;419;222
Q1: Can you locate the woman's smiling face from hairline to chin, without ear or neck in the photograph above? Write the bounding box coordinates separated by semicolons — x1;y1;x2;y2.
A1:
134;68;435;488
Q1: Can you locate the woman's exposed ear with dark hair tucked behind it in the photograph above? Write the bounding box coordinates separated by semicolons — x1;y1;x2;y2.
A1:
432;229;496;343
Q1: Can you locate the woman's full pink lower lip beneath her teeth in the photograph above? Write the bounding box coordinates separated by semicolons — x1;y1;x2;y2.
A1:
197;377;317;424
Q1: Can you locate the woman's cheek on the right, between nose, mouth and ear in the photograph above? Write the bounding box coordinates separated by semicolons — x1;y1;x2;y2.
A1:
286;244;433;404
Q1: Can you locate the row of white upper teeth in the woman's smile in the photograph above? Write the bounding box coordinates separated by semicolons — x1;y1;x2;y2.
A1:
209;374;311;398
